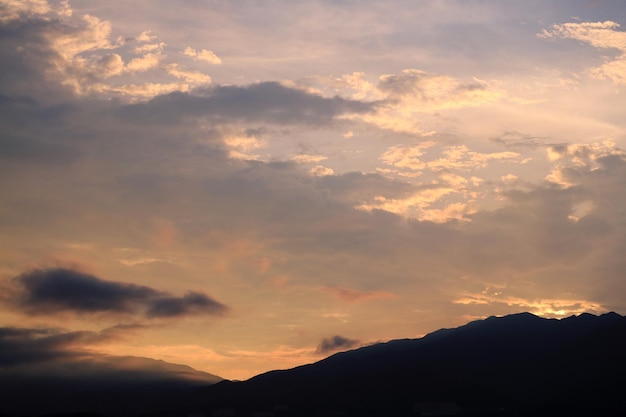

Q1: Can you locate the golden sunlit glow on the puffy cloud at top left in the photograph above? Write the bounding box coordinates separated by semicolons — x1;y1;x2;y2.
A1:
3;1;219;99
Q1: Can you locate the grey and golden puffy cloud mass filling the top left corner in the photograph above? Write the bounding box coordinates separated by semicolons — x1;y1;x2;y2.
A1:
0;1;217;102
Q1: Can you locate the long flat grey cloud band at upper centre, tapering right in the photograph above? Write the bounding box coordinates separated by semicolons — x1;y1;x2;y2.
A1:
121;82;376;127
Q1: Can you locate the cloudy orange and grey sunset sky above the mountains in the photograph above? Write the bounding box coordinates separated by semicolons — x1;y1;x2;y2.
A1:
0;0;626;379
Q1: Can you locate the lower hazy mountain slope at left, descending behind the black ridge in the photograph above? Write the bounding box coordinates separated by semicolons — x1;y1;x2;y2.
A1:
0;355;223;416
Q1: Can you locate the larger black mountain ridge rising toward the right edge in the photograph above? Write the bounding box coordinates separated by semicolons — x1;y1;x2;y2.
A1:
204;313;626;415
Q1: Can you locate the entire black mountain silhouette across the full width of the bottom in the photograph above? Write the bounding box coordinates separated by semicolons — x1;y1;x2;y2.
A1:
0;313;626;417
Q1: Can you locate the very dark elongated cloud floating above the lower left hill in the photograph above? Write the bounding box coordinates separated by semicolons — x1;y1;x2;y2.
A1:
10;268;228;318
